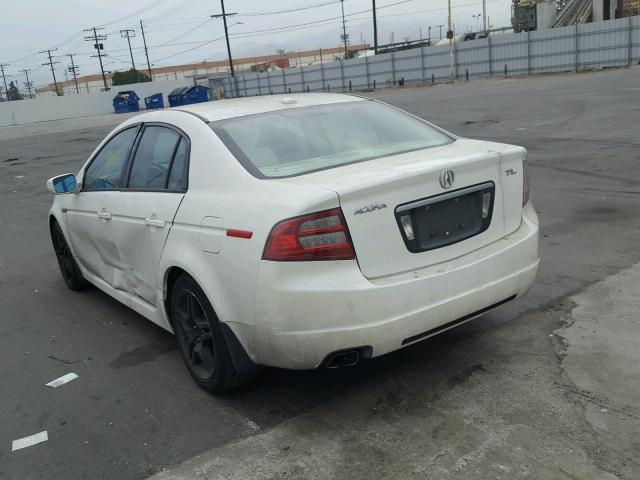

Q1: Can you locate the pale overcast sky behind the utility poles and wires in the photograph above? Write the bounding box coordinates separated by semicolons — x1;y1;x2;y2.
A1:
0;0;511;89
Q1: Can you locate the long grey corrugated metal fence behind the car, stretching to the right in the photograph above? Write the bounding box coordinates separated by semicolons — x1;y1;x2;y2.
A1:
223;17;640;97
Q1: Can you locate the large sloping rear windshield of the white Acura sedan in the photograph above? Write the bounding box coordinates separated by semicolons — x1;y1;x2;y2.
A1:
210;101;453;178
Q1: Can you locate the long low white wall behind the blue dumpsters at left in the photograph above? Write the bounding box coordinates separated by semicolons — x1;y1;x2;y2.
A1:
0;79;193;127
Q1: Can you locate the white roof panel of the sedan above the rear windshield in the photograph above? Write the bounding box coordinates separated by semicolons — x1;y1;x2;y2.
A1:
171;93;366;122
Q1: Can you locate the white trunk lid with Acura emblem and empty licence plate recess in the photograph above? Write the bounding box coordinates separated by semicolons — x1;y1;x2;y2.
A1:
281;139;523;278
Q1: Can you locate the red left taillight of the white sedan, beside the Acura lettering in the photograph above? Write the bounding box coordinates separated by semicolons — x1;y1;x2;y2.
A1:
262;208;355;262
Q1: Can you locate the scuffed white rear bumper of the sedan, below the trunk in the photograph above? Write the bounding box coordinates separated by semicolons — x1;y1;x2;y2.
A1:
230;204;539;369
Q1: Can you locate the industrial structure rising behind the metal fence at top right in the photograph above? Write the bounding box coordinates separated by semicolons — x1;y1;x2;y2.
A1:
511;0;640;33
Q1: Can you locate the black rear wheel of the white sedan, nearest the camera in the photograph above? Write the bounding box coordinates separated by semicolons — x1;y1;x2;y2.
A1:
171;273;252;393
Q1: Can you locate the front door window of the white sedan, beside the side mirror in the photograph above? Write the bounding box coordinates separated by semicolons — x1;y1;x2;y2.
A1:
82;128;138;190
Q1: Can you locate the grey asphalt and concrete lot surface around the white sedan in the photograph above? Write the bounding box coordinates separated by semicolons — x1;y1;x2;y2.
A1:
0;68;640;480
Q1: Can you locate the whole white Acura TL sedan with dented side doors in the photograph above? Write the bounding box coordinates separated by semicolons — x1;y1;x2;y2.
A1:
47;94;539;391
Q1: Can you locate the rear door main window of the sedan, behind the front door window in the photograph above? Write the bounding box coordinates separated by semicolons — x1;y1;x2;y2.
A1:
128;126;180;190
